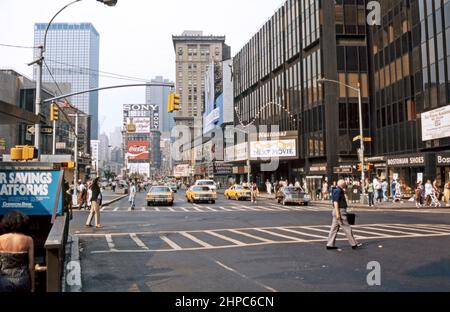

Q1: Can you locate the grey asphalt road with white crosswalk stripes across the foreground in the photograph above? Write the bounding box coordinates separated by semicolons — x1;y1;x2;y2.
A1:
71;193;450;292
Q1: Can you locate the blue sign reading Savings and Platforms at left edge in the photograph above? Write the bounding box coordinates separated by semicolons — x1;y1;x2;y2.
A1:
0;170;63;216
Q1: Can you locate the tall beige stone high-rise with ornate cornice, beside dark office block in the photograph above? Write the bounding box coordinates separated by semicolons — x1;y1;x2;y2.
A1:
172;31;230;127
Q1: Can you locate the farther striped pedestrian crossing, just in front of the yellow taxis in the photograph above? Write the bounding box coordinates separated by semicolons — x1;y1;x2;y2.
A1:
100;203;331;213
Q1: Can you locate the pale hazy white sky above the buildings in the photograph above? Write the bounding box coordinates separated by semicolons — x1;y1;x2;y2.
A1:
0;0;284;134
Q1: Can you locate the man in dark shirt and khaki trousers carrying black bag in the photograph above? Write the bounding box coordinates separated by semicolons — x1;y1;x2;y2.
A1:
327;180;362;250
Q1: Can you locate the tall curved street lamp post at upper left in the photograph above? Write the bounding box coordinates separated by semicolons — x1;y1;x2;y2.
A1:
28;0;117;151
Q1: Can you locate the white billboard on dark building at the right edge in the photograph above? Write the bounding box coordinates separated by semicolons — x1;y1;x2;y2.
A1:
422;105;450;142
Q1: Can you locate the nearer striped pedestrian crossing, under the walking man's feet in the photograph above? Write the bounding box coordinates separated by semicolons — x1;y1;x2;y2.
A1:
78;224;450;254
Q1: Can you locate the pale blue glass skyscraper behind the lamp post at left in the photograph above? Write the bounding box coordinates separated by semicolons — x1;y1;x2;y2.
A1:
34;23;99;140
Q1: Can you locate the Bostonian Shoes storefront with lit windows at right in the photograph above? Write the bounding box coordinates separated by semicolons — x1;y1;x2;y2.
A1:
386;153;434;191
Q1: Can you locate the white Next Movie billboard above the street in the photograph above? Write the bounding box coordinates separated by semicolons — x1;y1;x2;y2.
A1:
250;139;297;159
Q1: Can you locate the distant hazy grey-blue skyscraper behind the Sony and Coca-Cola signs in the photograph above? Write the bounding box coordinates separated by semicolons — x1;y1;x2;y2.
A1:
145;76;175;138
